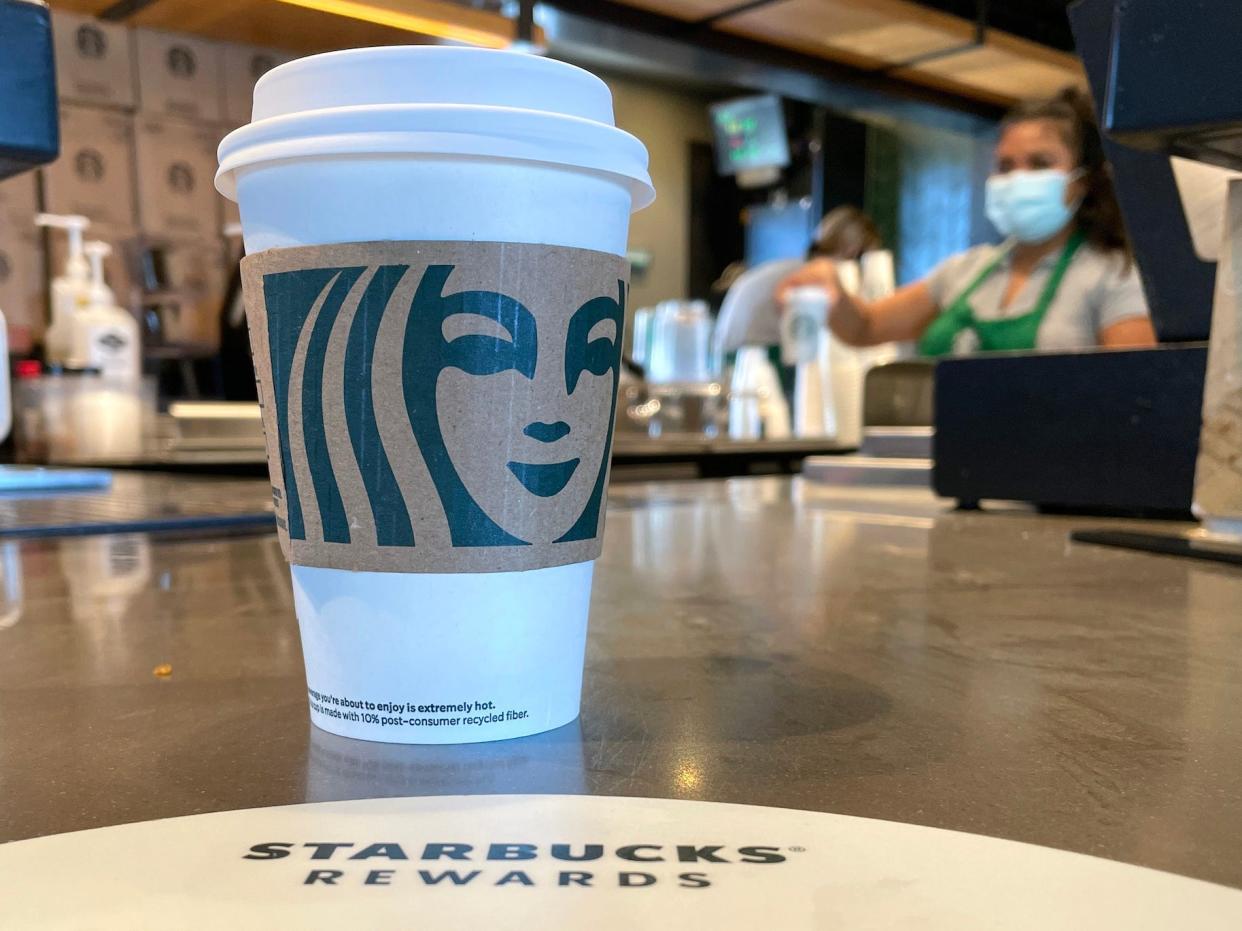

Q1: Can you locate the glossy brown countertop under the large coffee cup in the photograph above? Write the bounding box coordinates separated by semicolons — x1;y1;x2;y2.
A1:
0;479;1242;886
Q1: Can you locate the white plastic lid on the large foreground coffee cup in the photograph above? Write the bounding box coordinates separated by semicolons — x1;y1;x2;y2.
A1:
216;46;655;210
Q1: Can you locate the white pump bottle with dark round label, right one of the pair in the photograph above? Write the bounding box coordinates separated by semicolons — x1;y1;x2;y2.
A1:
70;241;142;382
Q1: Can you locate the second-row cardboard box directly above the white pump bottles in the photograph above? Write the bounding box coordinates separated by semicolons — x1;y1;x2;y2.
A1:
42;104;135;228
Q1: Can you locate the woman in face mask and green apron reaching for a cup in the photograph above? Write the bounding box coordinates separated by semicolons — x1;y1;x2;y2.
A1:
777;89;1155;356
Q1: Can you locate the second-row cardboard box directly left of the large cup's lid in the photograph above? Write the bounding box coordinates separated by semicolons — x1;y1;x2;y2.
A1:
137;115;228;238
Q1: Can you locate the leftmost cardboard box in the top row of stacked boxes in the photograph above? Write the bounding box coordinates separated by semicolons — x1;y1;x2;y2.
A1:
52;11;135;109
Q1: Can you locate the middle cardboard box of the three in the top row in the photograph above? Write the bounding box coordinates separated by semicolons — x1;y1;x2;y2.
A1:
134;29;221;123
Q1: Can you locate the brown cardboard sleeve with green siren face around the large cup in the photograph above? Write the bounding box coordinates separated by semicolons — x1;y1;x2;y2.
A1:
243;242;628;572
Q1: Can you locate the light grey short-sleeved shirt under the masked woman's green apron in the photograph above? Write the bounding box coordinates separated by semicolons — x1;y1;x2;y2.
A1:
927;242;1150;353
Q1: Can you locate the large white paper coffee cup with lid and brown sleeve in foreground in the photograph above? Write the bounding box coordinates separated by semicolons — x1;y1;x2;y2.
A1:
216;47;655;744
